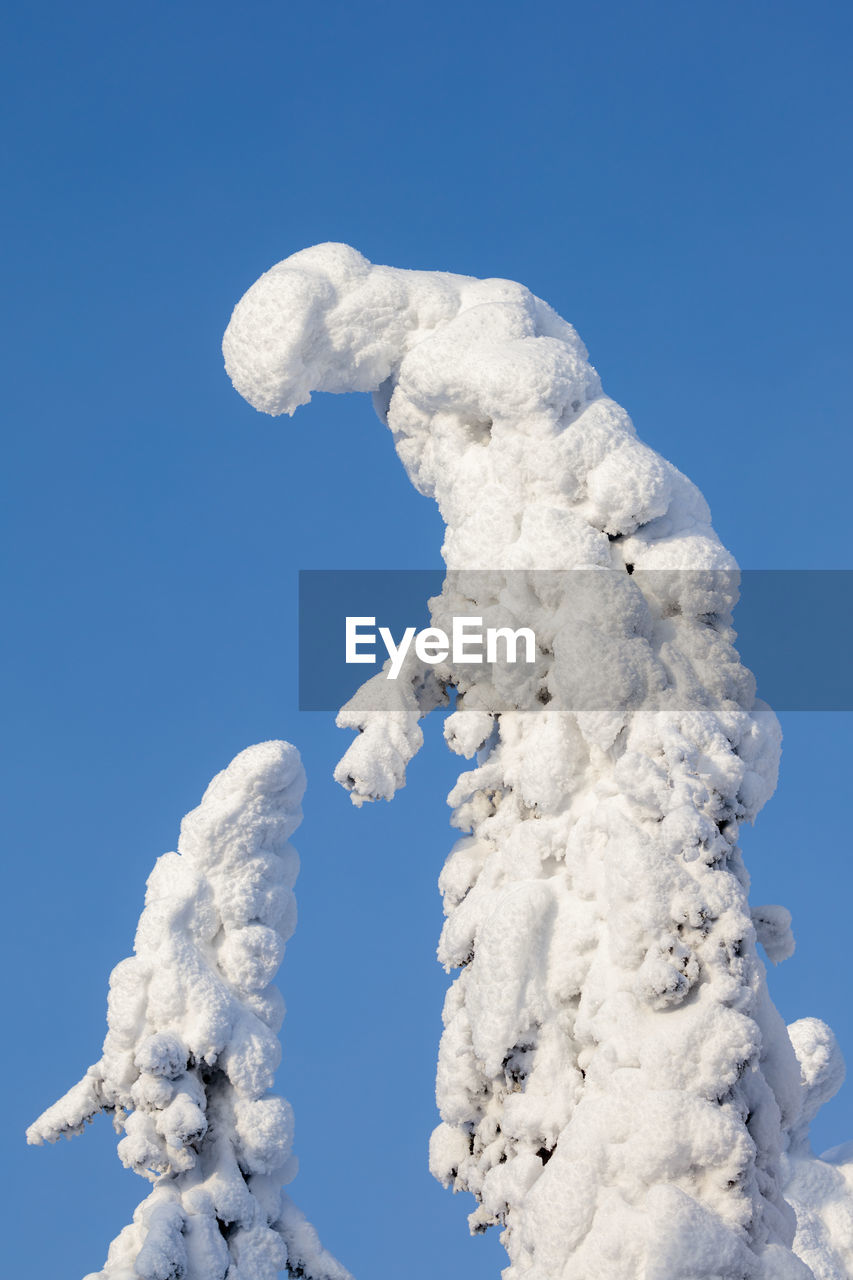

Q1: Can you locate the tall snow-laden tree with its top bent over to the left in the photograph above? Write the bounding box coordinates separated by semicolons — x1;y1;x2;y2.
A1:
223;244;853;1280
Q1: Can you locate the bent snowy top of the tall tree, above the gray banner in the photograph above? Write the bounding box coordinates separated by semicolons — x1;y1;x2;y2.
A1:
223;244;734;570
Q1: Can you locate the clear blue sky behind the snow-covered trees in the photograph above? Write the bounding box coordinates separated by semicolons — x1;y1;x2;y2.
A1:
3;0;853;1280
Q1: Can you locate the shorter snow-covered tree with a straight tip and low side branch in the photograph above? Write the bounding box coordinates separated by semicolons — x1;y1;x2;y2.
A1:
27;742;348;1280
